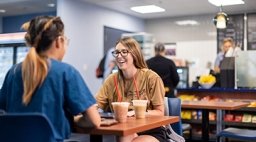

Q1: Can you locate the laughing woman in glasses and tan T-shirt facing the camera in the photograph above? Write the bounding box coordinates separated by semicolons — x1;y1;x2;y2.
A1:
96;37;166;142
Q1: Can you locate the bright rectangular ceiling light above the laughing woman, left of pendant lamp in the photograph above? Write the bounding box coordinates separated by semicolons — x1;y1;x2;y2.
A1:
131;5;165;14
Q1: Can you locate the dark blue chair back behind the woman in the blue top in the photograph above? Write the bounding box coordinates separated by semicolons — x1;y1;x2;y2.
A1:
0;113;56;142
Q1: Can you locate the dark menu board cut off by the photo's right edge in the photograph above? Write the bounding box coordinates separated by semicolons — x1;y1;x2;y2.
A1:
247;13;256;50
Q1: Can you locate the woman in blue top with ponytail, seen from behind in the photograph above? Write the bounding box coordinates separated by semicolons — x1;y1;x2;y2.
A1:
0;16;100;141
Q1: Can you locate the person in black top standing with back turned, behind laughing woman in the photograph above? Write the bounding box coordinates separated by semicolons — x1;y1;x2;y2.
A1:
147;42;180;98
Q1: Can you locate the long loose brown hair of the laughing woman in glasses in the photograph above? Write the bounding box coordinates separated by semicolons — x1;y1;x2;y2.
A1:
117;37;148;69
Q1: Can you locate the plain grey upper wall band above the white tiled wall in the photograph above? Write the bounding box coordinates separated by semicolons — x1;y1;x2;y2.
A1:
145;15;216;42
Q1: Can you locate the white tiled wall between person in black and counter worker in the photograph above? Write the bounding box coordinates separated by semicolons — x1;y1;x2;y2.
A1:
176;40;217;86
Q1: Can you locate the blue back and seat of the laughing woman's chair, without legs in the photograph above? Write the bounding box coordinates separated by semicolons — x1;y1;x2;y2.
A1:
165;97;182;136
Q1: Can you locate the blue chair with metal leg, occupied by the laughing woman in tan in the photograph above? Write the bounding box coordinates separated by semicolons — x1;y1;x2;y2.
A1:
165;97;192;139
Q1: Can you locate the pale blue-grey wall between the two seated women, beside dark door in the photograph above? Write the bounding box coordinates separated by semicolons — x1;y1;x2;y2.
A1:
57;0;144;94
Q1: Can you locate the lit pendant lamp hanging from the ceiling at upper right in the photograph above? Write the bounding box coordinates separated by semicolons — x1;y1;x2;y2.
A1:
213;6;228;29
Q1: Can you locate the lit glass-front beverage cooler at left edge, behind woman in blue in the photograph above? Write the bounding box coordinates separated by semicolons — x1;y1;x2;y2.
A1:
0;33;29;88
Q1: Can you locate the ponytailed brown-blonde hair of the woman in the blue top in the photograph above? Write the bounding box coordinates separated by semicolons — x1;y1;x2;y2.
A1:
22;16;64;105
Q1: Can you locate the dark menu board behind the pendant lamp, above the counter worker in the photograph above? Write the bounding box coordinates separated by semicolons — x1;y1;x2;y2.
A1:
217;14;245;52
